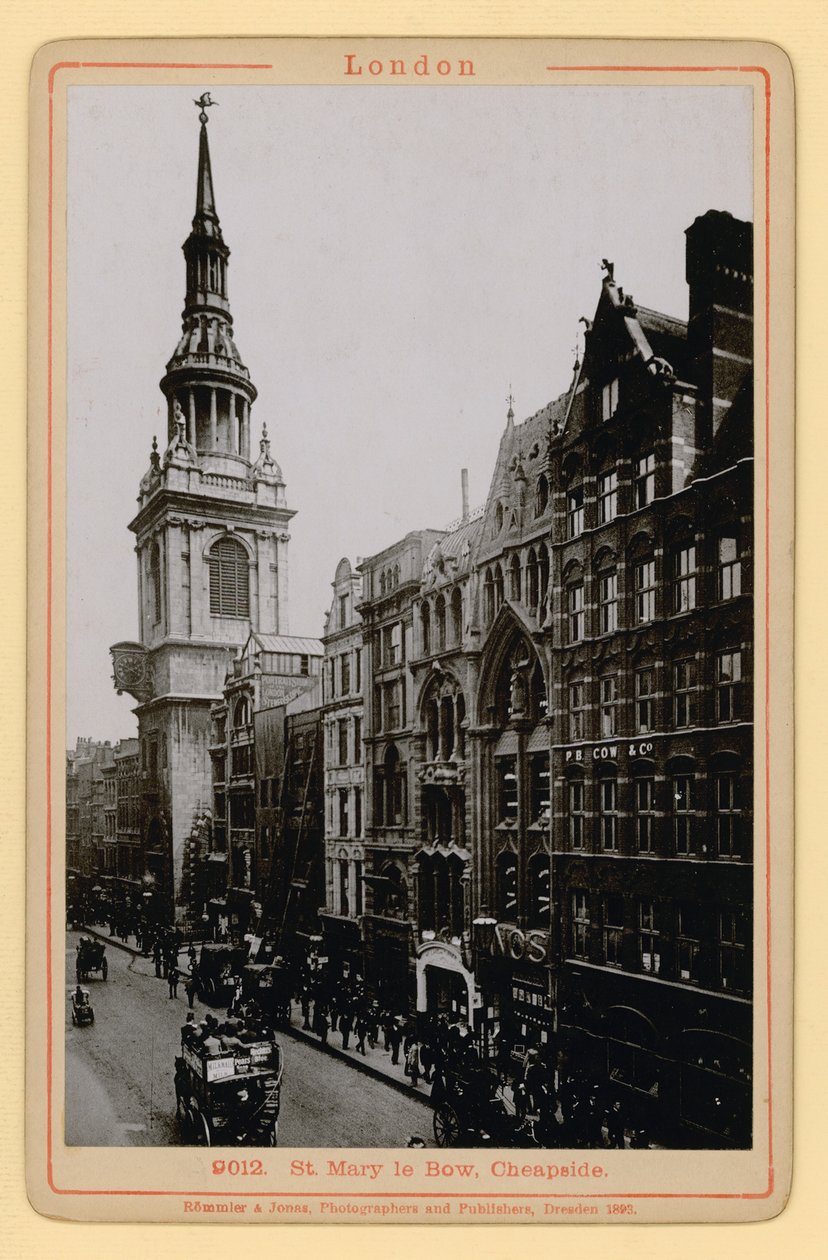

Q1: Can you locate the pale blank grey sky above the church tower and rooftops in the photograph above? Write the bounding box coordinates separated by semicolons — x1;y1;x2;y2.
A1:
67;82;754;746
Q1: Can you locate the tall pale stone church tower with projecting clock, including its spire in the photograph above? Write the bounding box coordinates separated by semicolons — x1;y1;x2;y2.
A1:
111;93;294;915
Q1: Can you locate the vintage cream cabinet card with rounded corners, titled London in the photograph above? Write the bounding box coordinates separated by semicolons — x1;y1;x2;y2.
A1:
28;38;794;1225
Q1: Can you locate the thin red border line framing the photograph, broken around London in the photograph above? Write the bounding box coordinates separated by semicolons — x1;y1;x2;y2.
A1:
45;62;774;1200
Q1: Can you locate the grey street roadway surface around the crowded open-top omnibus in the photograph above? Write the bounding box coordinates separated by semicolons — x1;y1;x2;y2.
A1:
66;932;434;1147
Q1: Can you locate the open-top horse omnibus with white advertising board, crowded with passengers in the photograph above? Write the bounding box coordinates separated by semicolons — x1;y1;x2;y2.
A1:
175;1041;284;1147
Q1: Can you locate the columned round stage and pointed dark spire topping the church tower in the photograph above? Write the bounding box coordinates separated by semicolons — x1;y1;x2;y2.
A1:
161;92;256;461
